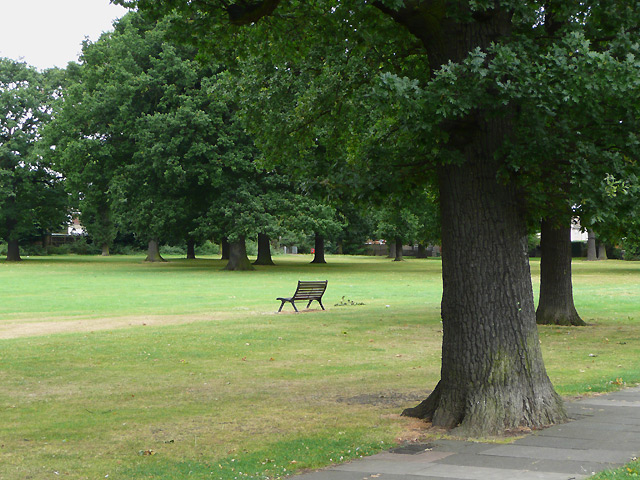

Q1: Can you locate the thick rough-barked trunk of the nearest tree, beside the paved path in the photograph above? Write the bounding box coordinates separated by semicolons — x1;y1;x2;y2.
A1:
403;127;567;437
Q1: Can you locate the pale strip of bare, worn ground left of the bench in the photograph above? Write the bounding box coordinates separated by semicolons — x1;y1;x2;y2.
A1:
0;312;264;340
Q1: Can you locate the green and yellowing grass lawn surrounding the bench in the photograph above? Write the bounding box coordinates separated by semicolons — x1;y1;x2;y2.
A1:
0;255;640;480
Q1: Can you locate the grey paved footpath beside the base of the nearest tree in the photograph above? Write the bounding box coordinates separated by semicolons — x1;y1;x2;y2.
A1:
294;388;640;480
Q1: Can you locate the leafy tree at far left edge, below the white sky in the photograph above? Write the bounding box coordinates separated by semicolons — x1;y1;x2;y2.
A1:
0;58;68;261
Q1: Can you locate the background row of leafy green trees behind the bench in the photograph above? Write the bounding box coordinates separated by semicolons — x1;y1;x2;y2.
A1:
2;13;438;270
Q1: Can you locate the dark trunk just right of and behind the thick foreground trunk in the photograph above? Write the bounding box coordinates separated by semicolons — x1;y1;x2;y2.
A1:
536;220;586;326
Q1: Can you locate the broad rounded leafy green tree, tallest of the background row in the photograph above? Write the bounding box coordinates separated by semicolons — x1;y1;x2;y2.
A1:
56;13;240;261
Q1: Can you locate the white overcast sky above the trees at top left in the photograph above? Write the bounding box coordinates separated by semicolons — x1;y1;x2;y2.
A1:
0;0;127;70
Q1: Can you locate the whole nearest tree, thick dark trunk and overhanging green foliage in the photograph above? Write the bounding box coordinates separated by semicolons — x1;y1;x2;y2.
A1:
122;0;638;434
